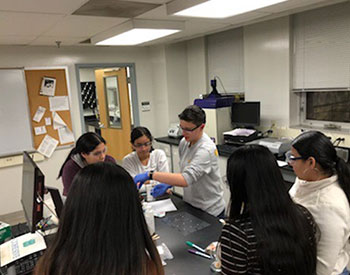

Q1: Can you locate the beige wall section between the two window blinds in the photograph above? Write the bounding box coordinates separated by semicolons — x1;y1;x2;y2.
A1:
244;17;290;126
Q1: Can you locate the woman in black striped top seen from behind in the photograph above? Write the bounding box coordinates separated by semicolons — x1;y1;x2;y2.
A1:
220;145;316;275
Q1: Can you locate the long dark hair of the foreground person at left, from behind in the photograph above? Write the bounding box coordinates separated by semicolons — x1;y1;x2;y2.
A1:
36;162;164;275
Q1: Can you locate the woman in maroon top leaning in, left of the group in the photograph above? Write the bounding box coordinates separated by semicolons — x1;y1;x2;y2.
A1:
57;132;115;196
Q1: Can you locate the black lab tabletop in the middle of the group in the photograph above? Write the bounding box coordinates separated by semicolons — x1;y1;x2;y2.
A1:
155;195;222;275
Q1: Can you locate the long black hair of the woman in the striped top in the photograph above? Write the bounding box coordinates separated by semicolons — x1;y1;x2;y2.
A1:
227;145;316;275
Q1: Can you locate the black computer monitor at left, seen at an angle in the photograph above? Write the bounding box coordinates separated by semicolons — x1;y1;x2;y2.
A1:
21;152;45;233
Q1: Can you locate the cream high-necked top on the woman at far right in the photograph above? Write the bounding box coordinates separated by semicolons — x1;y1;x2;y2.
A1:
289;175;350;275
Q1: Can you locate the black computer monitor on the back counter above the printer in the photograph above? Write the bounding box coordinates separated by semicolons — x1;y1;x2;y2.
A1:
231;101;260;128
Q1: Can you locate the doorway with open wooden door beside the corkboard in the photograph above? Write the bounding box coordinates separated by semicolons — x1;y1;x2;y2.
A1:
76;63;139;163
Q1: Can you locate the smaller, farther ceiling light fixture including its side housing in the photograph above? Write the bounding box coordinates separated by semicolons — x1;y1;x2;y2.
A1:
91;19;184;46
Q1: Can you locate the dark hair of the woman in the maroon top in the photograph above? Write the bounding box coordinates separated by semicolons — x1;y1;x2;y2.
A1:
57;132;106;179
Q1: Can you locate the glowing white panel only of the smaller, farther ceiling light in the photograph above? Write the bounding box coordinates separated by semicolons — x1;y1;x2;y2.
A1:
96;29;179;46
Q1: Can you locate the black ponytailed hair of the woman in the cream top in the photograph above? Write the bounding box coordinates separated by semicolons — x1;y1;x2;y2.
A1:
292;131;350;203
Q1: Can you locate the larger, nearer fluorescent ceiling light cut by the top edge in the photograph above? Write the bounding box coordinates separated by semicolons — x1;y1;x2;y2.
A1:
168;0;288;18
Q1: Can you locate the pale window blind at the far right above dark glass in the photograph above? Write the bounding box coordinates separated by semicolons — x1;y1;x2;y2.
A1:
293;2;350;90
